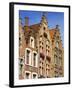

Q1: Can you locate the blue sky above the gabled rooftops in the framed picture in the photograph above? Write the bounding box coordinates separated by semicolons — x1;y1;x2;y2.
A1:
19;10;64;46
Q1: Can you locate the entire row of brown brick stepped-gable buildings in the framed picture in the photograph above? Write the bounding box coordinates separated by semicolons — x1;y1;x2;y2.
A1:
19;15;64;79
